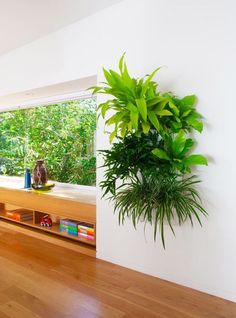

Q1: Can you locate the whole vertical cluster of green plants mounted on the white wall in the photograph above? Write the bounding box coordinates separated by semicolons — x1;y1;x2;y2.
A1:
91;55;207;248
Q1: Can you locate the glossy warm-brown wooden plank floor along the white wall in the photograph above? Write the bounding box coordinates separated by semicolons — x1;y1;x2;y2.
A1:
0;227;236;318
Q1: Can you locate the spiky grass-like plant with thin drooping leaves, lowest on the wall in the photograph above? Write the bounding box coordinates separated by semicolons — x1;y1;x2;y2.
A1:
112;170;207;248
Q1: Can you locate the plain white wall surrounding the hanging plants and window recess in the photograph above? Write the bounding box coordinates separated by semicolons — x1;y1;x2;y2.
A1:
0;0;236;301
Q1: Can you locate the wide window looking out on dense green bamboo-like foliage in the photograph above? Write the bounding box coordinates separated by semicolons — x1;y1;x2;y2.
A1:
0;98;96;185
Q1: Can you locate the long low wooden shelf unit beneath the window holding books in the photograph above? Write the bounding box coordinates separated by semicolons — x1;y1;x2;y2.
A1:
0;178;96;256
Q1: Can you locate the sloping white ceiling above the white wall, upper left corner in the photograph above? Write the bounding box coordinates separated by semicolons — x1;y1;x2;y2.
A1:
0;0;121;55
